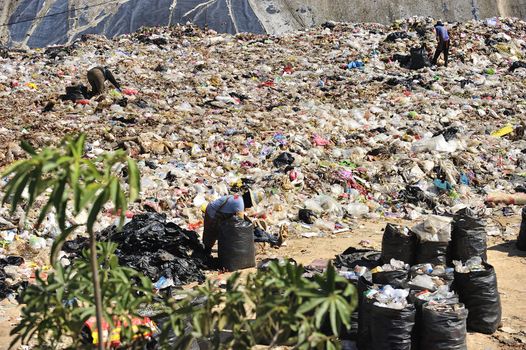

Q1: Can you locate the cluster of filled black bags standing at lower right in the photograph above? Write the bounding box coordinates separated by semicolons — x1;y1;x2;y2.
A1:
334;208;502;350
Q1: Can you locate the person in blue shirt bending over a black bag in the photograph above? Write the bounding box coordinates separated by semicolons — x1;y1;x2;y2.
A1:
203;190;263;254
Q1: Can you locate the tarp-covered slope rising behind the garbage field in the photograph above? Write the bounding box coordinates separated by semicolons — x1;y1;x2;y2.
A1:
0;0;526;47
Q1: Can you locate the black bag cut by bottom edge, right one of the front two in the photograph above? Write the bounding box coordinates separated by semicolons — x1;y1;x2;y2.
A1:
419;304;468;350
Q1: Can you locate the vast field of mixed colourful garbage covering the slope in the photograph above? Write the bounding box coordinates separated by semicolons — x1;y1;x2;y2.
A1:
0;18;526;243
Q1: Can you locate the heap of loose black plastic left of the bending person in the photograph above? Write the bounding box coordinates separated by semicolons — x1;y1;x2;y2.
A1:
63;213;211;289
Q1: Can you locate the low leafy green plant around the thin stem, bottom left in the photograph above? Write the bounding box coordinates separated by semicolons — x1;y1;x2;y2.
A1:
11;243;153;349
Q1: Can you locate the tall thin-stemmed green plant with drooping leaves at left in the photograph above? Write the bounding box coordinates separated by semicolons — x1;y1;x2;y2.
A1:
3;134;140;349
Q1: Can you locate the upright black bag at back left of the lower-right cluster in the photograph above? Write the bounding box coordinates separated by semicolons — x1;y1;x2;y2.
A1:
382;224;416;265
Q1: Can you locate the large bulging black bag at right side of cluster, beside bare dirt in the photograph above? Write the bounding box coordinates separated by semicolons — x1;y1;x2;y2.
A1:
453;263;502;334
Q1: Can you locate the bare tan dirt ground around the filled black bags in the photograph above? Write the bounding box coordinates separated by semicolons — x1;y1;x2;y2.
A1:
0;217;526;350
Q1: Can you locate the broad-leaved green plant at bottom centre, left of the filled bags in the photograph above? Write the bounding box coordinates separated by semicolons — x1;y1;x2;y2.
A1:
161;261;357;350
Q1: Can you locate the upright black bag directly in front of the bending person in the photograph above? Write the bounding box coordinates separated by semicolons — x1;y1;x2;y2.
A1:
218;216;256;271
